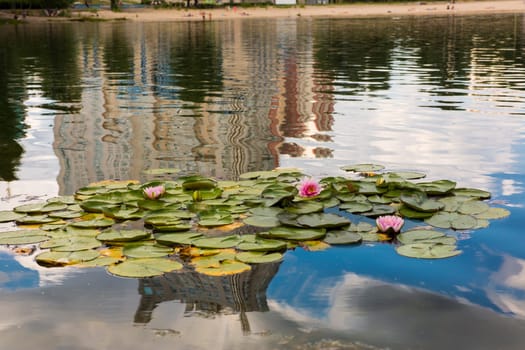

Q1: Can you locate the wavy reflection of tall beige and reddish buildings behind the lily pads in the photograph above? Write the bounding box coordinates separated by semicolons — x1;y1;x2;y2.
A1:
54;20;333;194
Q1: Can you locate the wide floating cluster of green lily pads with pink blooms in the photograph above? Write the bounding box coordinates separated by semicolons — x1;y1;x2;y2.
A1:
0;164;509;277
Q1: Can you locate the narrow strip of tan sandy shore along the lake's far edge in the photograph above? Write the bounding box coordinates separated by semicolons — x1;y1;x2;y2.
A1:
0;0;525;22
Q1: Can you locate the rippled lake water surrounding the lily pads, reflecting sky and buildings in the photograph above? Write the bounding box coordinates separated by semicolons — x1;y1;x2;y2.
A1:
0;14;525;350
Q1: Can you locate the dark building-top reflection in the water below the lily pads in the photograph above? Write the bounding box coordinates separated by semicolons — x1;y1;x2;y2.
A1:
135;263;280;332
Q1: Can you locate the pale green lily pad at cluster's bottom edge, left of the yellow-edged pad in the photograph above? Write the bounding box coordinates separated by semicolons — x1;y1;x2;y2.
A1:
107;258;183;278
